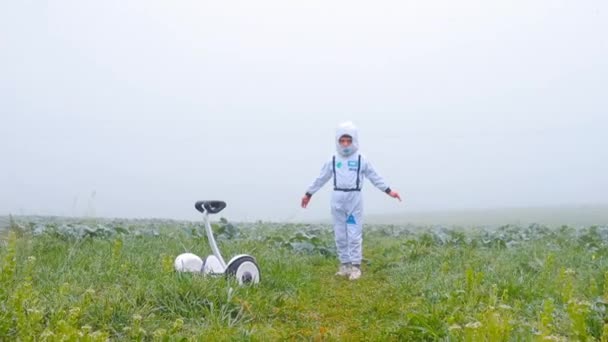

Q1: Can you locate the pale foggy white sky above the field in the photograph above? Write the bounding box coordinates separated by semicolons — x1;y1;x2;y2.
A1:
0;0;608;221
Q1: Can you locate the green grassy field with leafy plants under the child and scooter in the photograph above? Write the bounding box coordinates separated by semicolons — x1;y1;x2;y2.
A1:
0;220;608;341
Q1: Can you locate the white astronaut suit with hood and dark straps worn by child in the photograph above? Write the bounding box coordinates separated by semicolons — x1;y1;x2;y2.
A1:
306;122;391;265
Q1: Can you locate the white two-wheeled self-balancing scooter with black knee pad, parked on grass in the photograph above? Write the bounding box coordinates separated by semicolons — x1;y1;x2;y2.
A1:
175;201;261;285
